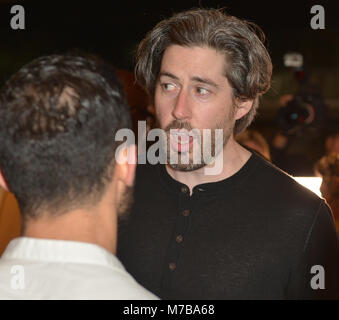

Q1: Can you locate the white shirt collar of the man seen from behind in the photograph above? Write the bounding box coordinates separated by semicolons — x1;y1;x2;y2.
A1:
1;237;124;269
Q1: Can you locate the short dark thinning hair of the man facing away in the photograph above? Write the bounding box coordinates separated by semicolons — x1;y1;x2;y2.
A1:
0;54;131;218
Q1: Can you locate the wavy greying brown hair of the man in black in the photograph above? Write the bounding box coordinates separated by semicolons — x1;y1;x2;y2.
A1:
135;9;272;134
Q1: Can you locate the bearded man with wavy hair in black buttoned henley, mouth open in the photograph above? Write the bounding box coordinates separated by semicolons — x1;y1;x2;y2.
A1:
118;9;339;299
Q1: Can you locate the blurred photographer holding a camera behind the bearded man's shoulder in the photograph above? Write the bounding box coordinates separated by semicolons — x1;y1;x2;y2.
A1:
270;87;327;176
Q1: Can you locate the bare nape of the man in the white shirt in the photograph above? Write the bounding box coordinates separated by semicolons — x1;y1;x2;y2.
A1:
23;208;117;254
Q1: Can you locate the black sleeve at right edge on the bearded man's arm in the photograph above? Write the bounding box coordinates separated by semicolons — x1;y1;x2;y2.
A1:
286;201;339;299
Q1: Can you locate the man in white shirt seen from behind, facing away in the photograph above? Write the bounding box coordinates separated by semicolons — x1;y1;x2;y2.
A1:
0;55;156;299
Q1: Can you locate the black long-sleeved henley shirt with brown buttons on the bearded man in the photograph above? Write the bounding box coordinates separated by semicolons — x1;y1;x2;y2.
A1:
118;154;339;299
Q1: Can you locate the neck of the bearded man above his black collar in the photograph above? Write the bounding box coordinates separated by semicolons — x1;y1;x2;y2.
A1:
166;139;251;194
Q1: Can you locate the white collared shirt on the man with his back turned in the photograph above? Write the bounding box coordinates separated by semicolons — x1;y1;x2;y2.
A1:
0;237;158;300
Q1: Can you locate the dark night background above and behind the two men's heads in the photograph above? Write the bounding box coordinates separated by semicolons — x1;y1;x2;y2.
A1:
0;0;339;134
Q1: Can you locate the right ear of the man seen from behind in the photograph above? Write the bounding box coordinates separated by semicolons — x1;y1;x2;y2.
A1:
114;144;137;187
